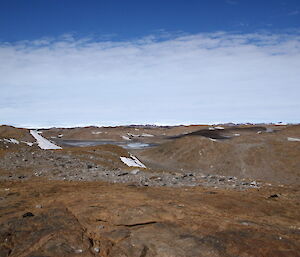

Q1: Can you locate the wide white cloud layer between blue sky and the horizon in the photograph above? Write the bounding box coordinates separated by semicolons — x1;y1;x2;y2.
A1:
0;32;300;126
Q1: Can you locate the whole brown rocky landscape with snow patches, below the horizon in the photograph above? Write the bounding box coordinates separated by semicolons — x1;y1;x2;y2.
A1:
0;124;300;257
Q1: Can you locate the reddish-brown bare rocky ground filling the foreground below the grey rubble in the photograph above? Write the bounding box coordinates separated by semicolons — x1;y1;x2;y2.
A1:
0;180;300;257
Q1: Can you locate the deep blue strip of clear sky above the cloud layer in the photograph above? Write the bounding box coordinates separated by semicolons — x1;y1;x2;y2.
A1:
0;0;300;42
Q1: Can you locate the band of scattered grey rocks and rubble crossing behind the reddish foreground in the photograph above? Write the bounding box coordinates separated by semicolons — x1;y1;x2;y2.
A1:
0;149;261;190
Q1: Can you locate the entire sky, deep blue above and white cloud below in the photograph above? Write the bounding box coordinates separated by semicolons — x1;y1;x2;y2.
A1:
0;0;300;127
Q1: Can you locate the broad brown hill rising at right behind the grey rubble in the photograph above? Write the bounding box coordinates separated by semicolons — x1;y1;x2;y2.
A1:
140;126;300;184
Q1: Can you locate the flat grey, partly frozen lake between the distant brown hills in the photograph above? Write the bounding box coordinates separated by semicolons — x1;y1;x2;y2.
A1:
55;140;156;149
